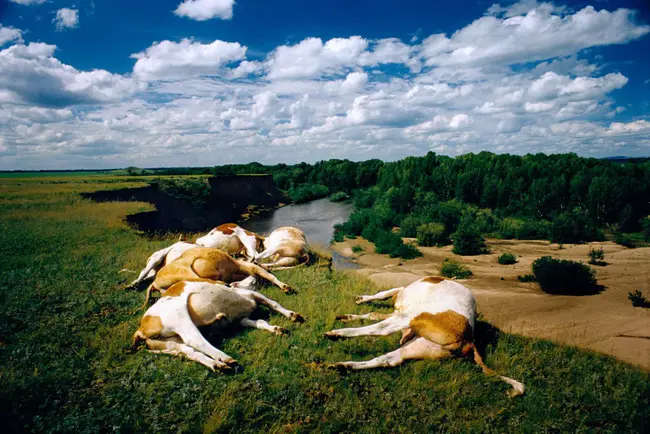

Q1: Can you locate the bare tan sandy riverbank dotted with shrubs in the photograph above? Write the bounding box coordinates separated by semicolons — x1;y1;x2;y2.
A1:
332;238;650;370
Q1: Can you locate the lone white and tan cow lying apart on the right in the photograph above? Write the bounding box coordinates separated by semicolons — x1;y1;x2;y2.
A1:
325;277;524;396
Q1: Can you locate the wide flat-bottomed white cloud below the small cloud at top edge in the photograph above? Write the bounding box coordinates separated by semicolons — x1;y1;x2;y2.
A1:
131;39;246;80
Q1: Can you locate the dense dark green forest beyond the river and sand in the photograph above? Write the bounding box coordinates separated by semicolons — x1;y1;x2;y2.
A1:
151;152;650;258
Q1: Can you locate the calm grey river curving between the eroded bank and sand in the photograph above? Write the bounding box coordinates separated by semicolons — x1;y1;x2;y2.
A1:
239;198;359;269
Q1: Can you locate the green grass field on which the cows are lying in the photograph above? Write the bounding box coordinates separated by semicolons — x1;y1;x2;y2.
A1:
0;176;650;433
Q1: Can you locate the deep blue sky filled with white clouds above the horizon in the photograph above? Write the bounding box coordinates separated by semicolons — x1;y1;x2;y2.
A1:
0;0;650;170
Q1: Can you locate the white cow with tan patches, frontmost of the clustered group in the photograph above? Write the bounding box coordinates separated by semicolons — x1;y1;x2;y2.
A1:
132;277;304;370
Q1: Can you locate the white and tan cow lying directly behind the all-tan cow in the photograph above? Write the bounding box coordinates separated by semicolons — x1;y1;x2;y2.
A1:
129;223;263;288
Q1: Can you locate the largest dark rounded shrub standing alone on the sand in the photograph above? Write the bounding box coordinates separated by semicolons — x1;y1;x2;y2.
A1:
532;256;598;295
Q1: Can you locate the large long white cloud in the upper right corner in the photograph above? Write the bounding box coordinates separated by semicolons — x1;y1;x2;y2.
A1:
421;2;650;66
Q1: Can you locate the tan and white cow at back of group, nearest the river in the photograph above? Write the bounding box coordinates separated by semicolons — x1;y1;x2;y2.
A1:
255;226;309;270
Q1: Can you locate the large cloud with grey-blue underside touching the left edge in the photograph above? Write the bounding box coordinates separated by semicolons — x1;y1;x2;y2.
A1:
0;42;139;106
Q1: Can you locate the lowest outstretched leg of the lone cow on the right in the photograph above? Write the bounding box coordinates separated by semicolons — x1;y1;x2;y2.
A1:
330;338;451;370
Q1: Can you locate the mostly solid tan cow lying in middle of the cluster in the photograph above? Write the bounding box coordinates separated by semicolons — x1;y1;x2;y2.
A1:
143;247;294;307
